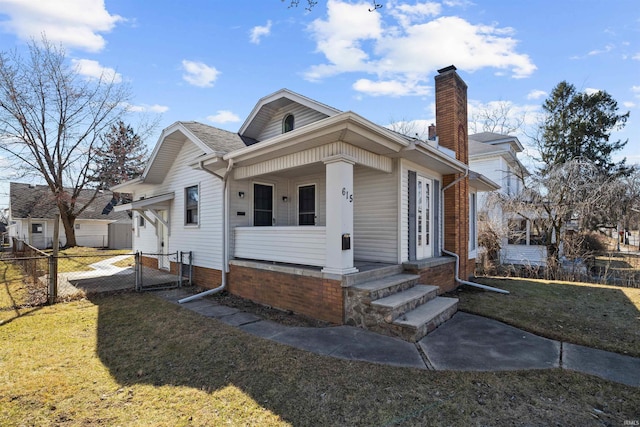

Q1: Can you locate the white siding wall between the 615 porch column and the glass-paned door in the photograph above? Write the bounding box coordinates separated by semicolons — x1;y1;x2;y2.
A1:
353;166;398;263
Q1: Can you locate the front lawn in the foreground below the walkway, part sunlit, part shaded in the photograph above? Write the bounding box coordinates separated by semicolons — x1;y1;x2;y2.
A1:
0;293;640;426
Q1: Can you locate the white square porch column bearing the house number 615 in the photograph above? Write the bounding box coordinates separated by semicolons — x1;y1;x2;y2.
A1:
322;155;358;274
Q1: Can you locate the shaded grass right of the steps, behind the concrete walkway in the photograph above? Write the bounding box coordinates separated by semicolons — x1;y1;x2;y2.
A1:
455;278;640;357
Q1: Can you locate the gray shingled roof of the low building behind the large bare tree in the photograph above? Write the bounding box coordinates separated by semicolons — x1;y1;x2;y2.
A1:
9;182;129;221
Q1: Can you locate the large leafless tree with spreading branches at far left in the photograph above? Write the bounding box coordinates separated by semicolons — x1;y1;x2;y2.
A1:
0;36;129;246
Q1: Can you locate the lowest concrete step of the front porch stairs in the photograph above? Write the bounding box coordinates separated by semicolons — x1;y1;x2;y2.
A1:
393;297;458;342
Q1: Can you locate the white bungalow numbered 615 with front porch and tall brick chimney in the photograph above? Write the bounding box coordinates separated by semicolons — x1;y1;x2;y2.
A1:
113;66;497;340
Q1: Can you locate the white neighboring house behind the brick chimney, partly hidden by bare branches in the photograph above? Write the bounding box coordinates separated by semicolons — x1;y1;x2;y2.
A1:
469;132;547;265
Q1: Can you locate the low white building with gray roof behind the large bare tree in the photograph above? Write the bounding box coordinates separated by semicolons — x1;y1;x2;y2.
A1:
7;182;130;249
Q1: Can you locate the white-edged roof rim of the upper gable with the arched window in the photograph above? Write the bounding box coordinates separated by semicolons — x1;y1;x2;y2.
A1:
238;89;342;139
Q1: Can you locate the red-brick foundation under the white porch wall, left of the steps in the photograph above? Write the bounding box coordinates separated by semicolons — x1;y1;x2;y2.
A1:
228;264;344;324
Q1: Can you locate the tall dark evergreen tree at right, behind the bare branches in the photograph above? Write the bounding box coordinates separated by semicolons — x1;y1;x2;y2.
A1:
538;81;630;176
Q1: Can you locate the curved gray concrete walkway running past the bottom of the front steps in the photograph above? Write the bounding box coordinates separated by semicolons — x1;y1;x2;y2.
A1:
156;289;640;387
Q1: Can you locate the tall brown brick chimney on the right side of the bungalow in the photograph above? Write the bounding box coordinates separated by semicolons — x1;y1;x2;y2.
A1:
435;65;475;280
